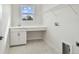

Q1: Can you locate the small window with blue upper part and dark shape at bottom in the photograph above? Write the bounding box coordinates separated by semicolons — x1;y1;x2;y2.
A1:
21;6;34;21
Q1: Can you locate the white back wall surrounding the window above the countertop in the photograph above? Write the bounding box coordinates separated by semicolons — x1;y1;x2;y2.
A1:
11;4;42;26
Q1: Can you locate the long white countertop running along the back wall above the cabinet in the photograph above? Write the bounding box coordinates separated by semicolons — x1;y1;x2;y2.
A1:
10;26;47;31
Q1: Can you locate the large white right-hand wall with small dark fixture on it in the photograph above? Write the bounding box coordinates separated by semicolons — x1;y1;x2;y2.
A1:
43;5;79;53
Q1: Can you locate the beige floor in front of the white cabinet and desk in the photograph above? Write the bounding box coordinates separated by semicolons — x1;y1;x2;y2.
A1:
9;40;55;54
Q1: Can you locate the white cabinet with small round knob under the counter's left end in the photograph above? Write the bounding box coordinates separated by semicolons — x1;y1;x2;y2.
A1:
10;29;27;45
